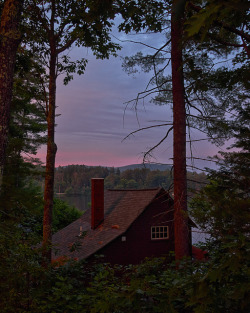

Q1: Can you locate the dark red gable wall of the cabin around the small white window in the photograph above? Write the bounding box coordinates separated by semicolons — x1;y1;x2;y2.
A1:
90;193;174;264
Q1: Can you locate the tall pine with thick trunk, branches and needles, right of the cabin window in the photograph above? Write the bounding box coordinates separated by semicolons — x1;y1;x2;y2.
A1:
120;0;249;259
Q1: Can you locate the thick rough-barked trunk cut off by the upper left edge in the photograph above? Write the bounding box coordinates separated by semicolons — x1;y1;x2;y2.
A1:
0;0;23;188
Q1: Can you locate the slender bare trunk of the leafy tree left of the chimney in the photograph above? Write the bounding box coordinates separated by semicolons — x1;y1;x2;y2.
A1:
43;47;57;266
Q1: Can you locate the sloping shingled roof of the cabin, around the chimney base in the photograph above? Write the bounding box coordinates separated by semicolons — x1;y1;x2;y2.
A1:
52;188;163;259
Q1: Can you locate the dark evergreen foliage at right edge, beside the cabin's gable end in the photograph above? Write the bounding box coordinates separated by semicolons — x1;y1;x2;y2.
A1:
191;105;250;240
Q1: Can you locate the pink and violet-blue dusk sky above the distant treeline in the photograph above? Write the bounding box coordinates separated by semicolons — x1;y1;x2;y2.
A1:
37;28;223;170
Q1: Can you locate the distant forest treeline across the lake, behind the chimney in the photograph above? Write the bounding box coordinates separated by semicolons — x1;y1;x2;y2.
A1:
55;165;206;195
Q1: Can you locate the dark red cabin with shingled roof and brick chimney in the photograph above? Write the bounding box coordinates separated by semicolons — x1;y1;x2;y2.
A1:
52;178;195;265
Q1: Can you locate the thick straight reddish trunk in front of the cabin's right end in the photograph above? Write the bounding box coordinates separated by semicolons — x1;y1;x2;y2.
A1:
171;0;190;260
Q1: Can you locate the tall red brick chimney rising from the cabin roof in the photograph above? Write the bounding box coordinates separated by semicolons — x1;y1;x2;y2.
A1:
91;178;104;229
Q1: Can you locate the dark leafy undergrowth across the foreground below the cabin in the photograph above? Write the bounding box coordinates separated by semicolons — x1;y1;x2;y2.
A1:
15;250;249;313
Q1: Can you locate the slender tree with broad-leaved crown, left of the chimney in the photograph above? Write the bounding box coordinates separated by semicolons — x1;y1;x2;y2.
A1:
29;0;118;263
